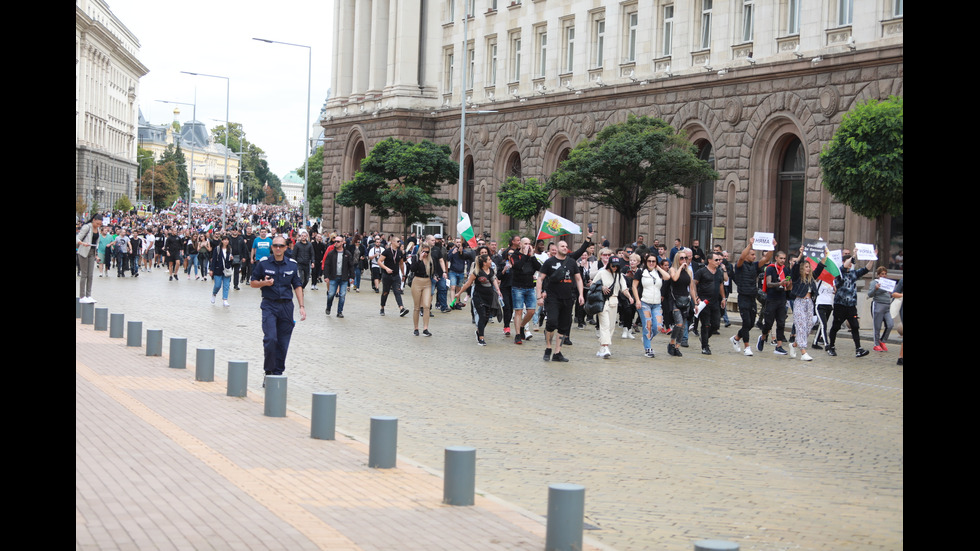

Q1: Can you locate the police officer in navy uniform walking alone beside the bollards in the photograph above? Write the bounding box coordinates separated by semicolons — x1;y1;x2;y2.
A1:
251;235;306;382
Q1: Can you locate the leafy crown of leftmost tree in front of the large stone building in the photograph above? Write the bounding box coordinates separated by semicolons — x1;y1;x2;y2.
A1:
337;138;459;232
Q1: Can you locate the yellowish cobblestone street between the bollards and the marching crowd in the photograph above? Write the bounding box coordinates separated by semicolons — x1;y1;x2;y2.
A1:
76;270;904;551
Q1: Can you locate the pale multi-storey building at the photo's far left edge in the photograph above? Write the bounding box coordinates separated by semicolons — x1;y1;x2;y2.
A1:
75;0;149;208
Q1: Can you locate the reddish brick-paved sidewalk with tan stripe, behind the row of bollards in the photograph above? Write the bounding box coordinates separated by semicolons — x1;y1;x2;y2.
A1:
75;319;608;550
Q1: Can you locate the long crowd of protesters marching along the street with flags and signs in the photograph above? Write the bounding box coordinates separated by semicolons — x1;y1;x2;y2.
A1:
76;203;903;364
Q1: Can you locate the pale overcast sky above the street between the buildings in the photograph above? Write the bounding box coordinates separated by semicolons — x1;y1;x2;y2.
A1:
106;0;333;178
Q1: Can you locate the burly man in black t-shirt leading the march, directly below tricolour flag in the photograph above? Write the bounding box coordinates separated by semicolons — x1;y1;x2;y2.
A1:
536;241;585;362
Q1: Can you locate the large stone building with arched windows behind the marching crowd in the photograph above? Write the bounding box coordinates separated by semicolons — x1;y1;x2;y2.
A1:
321;0;904;250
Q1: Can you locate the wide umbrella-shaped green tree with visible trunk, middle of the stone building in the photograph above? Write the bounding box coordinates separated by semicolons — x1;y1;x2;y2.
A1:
548;115;718;247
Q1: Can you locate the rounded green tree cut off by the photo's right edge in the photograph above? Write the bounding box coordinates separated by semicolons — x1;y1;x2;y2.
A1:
820;96;905;258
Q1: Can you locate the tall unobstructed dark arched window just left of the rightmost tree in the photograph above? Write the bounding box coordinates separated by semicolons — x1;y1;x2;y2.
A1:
776;136;806;251
